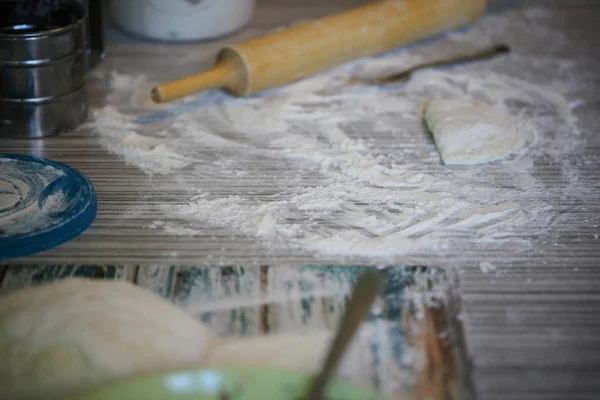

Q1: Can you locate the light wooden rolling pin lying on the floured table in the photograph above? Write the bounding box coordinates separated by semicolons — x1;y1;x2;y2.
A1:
152;0;487;103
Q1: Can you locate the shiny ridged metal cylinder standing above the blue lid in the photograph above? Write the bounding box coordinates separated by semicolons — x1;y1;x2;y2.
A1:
0;0;88;138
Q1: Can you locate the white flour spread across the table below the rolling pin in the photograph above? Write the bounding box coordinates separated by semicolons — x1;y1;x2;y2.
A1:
93;10;579;260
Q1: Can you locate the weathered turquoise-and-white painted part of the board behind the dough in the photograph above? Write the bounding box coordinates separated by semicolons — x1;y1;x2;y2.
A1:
0;266;463;398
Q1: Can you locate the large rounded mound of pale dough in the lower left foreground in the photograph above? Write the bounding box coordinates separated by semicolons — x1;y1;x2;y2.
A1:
0;279;212;400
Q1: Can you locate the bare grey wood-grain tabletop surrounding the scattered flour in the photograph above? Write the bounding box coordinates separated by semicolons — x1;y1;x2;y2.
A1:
0;0;600;400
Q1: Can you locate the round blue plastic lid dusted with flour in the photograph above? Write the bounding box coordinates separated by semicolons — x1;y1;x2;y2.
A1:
0;153;98;260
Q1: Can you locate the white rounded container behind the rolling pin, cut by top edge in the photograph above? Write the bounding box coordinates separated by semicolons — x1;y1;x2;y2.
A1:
110;0;255;42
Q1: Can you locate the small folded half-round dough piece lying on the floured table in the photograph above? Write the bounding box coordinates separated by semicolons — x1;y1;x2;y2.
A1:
425;99;531;165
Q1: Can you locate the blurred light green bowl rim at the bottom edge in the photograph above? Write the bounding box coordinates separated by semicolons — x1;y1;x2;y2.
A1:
70;368;384;400
